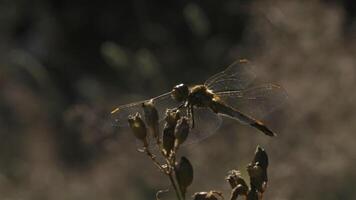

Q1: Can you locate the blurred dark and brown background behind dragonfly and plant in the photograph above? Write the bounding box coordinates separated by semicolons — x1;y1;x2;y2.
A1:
0;0;356;200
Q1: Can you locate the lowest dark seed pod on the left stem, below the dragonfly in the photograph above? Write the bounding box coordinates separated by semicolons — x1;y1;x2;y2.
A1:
175;157;193;195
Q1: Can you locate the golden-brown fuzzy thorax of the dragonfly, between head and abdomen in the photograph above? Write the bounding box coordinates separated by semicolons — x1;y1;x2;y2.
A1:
188;85;214;107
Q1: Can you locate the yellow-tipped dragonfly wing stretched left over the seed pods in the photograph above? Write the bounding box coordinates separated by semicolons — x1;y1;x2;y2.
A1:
111;92;179;127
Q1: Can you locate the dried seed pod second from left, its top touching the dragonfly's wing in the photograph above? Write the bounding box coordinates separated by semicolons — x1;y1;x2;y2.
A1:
142;100;159;138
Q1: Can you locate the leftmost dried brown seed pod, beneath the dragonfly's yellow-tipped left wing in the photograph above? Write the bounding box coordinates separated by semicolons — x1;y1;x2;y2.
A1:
128;113;147;146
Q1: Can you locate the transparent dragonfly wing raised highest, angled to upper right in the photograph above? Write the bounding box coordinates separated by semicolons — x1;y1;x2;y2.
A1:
204;60;256;92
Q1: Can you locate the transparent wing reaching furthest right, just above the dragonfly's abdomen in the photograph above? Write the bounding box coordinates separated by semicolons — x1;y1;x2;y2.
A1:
216;83;288;119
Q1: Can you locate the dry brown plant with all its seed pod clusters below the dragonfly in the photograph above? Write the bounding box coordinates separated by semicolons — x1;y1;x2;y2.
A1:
128;101;268;200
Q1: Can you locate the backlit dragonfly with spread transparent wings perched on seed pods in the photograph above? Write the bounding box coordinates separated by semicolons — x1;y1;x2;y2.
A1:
111;59;288;141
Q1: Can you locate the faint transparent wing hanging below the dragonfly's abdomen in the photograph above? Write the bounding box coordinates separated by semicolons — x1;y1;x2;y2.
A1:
184;108;222;145
